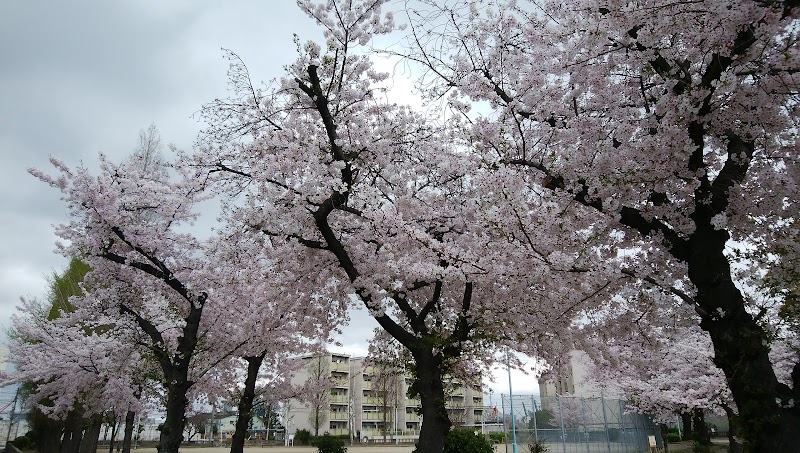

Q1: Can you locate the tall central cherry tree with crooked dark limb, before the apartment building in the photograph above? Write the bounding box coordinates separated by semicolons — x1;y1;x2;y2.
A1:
191;1;613;452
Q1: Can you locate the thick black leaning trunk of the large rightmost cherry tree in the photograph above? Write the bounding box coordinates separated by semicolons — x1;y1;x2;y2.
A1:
688;226;800;452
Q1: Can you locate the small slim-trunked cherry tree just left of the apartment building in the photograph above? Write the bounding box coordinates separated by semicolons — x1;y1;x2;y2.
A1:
201;228;341;453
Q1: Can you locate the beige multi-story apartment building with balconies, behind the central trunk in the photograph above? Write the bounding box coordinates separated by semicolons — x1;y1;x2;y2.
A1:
286;354;484;441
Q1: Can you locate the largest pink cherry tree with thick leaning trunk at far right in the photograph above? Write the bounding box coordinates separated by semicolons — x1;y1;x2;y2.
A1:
408;0;800;444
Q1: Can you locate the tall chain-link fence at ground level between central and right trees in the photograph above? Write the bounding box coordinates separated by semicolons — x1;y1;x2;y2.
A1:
484;395;663;453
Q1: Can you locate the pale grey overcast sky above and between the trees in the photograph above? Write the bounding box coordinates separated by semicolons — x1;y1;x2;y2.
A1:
0;0;538;393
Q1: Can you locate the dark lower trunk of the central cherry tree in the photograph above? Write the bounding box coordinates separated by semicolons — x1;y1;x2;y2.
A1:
412;351;451;453
